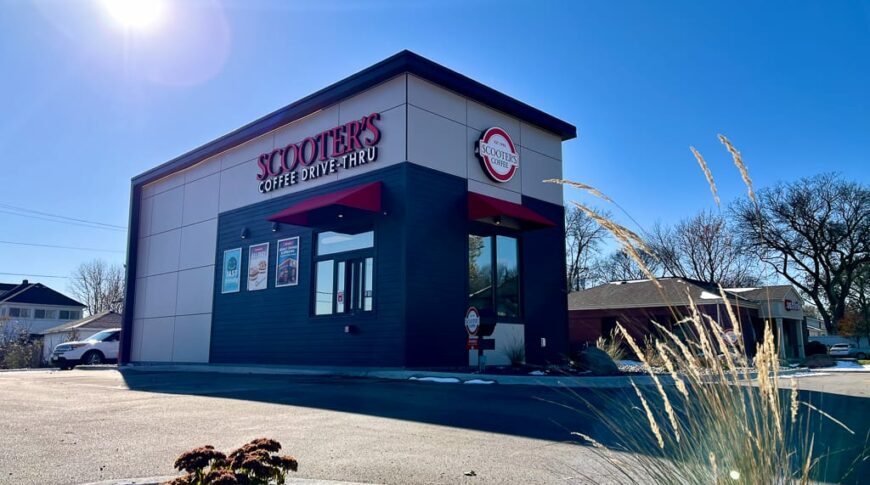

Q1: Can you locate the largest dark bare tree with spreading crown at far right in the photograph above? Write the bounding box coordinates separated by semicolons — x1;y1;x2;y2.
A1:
732;174;870;334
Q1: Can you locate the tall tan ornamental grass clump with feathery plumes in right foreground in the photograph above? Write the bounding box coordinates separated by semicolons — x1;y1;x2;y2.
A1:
566;135;866;485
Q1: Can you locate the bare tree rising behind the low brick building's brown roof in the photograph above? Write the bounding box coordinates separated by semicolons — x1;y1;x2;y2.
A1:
648;211;761;287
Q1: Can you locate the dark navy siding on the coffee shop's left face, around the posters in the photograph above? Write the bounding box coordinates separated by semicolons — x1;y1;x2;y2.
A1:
211;164;407;366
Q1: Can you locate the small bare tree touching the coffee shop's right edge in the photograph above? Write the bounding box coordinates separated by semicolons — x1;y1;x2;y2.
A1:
565;207;607;291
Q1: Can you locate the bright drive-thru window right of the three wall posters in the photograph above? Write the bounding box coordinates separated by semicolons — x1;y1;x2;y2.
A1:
314;231;374;315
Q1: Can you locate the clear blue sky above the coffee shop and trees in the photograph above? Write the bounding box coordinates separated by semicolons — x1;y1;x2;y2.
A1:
0;0;870;288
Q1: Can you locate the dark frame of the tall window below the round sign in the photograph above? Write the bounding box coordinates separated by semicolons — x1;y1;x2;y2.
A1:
465;229;526;323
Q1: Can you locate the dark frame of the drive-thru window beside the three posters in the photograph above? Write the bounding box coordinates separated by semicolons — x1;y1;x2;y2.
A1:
309;228;378;319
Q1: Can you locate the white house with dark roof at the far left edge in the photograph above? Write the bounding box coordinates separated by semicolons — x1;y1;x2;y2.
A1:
0;280;85;335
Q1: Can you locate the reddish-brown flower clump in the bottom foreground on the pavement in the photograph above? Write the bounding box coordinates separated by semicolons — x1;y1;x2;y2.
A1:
164;438;299;485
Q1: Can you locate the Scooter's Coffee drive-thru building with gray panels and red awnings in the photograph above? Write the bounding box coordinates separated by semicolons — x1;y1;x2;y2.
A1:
121;51;576;367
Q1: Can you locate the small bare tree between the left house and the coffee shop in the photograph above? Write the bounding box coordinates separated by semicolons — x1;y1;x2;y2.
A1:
70;259;124;315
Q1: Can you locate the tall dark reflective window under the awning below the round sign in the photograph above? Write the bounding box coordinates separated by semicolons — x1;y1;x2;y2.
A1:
468;234;520;318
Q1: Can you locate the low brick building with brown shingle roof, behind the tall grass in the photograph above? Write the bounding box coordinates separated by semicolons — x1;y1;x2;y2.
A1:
568;278;806;358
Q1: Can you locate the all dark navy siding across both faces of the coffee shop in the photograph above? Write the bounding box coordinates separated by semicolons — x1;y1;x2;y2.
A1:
211;163;568;367
